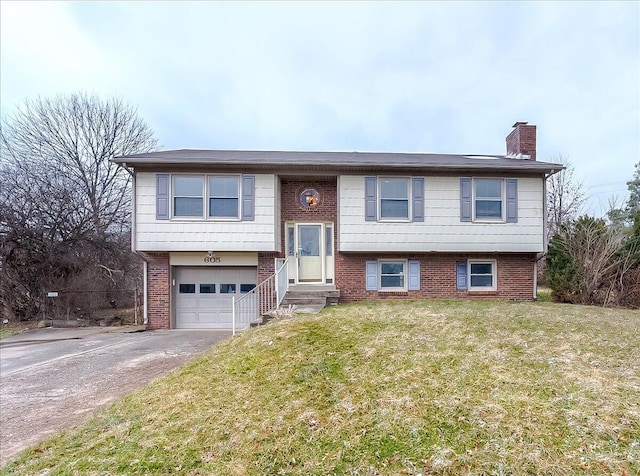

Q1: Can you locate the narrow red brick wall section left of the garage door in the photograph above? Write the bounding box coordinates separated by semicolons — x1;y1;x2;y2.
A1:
141;253;171;330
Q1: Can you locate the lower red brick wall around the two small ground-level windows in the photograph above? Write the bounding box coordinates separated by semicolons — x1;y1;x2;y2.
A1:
336;253;536;302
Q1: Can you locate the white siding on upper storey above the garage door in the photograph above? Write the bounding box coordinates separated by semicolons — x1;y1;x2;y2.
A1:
134;172;280;251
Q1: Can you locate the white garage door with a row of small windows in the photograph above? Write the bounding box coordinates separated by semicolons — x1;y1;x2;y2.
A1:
175;267;257;329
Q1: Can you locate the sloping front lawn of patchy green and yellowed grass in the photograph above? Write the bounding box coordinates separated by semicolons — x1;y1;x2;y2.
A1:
0;301;640;475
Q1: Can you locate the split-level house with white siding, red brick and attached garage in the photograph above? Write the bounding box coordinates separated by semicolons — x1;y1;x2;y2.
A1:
114;122;562;329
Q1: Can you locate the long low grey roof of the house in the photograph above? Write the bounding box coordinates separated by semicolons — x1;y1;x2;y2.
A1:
113;149;564;174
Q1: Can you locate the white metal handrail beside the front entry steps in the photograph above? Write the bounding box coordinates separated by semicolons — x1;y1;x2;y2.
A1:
231;258;289;335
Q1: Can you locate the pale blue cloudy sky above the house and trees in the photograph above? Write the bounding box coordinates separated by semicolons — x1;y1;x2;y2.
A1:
0;0;640;215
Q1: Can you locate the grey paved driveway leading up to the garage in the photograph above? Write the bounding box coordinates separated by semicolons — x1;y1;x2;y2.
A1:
0;327;231;463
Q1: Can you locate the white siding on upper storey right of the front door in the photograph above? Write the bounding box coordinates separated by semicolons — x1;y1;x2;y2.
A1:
337;175;544;253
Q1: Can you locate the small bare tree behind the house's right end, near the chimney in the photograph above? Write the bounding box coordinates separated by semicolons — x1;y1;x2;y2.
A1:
547;155;585;238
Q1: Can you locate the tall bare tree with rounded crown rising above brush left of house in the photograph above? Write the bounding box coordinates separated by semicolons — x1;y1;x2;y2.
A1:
0;93;157;234
